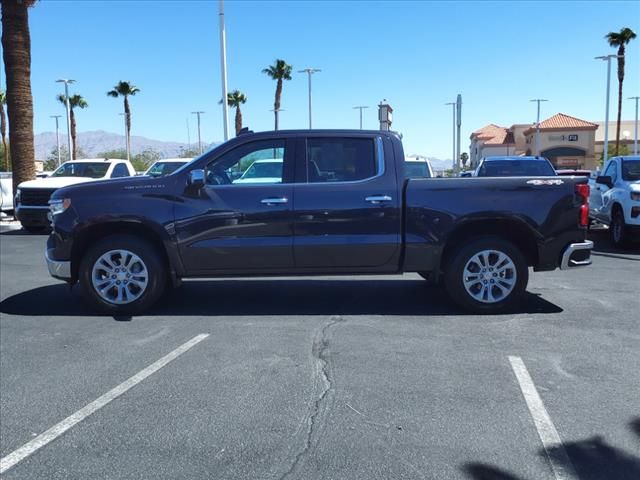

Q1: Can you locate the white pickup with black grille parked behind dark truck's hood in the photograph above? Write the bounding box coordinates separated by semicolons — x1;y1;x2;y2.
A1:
14;158;135;232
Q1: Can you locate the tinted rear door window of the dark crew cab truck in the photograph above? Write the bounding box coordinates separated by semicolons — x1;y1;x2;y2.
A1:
306;138;378;183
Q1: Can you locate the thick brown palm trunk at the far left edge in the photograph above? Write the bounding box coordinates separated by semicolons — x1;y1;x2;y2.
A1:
1;0;36;192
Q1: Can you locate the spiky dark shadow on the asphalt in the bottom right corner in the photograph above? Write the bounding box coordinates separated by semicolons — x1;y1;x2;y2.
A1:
462;417;640;480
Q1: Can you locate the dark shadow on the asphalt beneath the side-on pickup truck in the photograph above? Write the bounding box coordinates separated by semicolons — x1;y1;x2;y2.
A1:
0;279;563;316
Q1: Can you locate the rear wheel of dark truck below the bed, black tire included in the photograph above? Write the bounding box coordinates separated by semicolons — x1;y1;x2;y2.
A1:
444;236;529;313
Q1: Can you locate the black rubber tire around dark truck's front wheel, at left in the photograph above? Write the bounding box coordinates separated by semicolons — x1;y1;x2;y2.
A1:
78;235;169;315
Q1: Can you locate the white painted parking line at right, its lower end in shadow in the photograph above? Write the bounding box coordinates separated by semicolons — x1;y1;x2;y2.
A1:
509;356;578;480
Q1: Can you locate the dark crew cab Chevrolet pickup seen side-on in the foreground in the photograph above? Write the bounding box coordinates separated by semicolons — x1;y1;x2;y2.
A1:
46;130;592;314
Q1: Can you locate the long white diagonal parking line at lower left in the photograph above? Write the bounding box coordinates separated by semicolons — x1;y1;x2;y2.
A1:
0;333;209;475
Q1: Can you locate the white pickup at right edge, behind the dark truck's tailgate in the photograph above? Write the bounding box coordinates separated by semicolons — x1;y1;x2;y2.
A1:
589;156;640;248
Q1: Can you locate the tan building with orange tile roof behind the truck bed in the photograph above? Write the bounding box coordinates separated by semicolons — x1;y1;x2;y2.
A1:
469;113;620;170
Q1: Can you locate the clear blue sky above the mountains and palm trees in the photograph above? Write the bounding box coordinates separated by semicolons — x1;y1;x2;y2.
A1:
3;0;640;158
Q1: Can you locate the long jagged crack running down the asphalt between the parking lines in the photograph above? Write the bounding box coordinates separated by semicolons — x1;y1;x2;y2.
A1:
280;315;344;480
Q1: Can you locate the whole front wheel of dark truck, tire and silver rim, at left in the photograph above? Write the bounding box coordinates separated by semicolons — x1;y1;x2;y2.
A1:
78;235;167;315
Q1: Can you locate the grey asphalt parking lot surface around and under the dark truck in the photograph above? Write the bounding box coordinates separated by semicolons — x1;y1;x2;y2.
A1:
0;230;640;480
